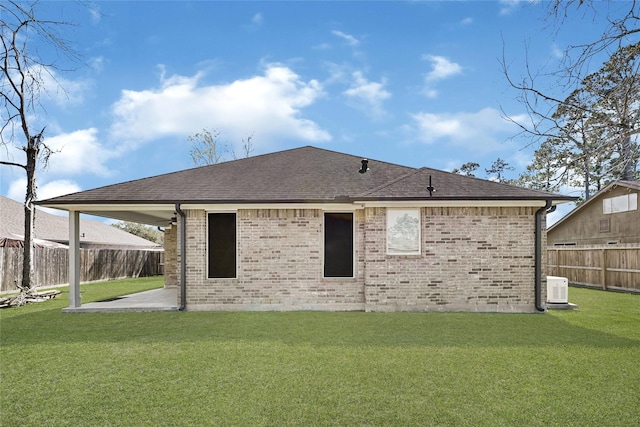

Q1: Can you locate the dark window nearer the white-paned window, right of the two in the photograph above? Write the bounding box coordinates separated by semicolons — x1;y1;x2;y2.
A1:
324;212;353;277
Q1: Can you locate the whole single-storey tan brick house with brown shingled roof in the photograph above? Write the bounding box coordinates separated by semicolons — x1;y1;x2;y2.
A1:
40;147;572;312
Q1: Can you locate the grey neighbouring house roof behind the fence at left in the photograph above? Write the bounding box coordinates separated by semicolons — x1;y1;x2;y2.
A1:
0;196;159;248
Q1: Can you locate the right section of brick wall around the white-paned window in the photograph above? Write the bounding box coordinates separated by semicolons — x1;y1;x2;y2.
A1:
365;208;535;312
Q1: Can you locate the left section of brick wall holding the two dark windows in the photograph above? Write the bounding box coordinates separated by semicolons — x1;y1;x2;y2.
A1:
187;209;364;310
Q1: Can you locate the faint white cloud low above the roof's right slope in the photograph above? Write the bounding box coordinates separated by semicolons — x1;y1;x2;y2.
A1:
411;108;515;153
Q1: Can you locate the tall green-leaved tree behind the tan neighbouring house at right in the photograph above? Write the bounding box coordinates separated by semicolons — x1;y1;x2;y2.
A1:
519;43;640;199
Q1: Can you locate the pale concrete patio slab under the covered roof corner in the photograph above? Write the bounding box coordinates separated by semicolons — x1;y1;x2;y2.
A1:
62;288;178;313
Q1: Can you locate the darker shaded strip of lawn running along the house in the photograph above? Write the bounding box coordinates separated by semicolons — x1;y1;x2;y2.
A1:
0;307;640;348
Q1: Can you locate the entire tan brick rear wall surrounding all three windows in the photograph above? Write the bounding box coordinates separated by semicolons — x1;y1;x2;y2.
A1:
175;208;545;312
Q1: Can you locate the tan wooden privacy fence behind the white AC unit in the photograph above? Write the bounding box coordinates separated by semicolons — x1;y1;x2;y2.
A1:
547;246;640;292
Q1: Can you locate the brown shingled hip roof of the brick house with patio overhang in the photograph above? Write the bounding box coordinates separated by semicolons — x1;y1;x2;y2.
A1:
40;147;573;225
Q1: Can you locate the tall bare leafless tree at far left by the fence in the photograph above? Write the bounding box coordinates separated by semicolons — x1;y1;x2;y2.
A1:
0;0;79;294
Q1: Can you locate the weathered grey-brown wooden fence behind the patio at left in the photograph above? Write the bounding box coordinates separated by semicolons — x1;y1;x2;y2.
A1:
0;248;164;292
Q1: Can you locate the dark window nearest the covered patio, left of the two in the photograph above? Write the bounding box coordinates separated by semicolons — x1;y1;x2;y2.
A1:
208;213;236;279
